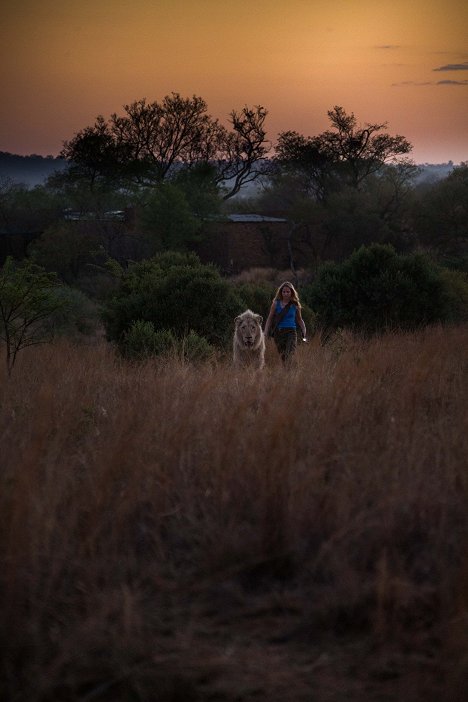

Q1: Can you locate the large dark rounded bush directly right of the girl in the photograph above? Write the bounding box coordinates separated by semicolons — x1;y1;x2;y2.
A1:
304;244;460;333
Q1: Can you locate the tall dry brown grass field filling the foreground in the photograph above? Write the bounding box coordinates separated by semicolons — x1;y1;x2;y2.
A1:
0;327;468;702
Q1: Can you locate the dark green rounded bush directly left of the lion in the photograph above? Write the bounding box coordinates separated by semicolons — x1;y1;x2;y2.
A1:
103;252;242;344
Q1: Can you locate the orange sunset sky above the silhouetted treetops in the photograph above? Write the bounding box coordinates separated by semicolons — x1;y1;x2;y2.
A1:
0;0;468;163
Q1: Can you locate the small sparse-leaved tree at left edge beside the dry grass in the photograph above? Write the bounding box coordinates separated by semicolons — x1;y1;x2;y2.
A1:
0;257;64;375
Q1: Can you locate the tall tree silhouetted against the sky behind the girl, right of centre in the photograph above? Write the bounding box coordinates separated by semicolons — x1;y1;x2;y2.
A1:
263;107;416;264
